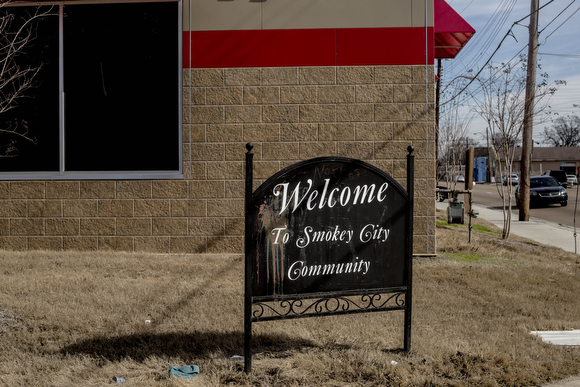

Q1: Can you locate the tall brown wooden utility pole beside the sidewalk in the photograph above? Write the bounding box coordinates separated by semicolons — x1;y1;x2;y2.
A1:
519;0;540;221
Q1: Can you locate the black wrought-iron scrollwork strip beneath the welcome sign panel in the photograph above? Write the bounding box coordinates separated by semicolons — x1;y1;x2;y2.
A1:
252;292;405;321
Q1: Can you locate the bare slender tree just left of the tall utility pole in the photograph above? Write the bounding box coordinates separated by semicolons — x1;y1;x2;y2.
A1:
473;57;563;239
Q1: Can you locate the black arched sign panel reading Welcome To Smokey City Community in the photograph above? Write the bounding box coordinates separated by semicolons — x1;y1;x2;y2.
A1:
252;158;406;296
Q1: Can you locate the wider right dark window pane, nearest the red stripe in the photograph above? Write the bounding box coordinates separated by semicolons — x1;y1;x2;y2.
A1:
64;3;180;171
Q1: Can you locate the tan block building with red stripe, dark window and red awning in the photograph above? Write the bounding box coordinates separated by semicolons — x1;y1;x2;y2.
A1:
0;0;474;254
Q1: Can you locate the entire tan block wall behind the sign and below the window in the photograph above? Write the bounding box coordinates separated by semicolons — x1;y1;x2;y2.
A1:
0;66;435;254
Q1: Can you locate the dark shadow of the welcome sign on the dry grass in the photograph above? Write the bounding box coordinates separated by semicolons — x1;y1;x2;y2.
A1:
59;332;318;362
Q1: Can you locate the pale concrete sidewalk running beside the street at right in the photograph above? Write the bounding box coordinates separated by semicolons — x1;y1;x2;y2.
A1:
437;202;580;255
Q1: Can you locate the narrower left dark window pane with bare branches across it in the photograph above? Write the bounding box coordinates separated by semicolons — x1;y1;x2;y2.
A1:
0;7;59;172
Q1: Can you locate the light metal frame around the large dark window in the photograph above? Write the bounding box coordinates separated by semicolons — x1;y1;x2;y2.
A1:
0;0;183;181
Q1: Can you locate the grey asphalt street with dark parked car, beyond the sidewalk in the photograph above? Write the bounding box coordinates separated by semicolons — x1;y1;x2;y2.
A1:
456;184;580;227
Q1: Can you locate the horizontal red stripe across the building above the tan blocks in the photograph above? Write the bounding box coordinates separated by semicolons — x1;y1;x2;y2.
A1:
183;27;434;68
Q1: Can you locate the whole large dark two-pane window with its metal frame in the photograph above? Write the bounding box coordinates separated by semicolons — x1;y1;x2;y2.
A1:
0;2;182;179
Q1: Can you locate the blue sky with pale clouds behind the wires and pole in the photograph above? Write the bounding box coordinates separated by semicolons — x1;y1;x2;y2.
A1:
441;0;580;146
